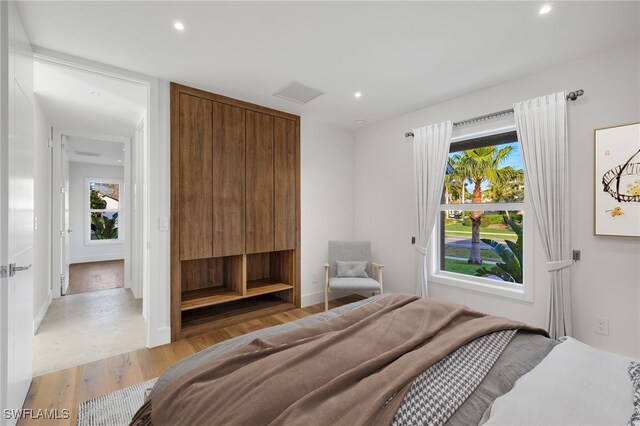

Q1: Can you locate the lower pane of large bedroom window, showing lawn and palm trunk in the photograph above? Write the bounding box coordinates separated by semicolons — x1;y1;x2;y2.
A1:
440;210;523;284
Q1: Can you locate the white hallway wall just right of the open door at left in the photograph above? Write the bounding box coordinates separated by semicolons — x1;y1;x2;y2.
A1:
33;99;51;333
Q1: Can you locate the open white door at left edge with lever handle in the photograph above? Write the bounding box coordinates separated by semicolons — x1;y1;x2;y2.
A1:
0;2;34;424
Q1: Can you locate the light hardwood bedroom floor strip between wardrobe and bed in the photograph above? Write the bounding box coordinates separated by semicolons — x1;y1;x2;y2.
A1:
18;295;362;426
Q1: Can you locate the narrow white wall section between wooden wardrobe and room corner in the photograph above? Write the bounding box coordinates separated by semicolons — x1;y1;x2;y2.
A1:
300;117;354;306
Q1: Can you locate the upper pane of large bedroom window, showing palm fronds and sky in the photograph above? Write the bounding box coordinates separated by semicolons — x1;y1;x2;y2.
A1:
444;141;524;204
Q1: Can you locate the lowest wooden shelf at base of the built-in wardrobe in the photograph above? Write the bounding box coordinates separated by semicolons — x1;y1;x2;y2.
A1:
179;294;296;338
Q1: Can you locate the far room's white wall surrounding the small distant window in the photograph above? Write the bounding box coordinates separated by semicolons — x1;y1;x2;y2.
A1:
69;162;127;263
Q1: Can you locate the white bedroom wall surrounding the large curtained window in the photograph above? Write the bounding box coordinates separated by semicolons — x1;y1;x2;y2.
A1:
352;43;640;359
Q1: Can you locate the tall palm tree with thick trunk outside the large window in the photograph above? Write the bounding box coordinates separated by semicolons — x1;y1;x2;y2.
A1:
457;145;519;265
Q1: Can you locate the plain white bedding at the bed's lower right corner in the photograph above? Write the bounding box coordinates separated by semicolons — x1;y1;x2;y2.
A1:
485;338;634;426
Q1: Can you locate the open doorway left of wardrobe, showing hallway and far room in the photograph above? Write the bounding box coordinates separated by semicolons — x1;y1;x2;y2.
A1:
33;57;149;375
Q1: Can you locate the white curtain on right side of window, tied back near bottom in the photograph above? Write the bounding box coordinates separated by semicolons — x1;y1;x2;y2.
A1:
513;92;573;339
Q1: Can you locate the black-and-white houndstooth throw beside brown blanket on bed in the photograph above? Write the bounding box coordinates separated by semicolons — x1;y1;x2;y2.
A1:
391;330;520;426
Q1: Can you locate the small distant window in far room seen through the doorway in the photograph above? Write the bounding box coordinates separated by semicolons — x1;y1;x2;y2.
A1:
86;178;122;244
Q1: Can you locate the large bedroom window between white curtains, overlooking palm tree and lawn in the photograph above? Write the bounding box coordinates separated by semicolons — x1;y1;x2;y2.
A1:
429;131;532;300
